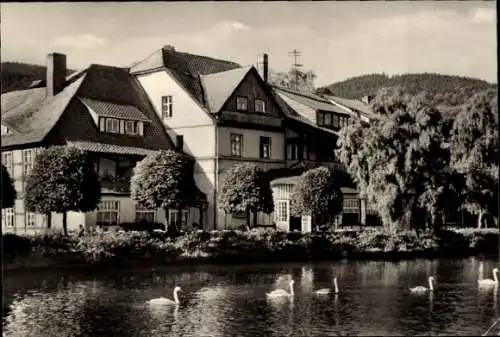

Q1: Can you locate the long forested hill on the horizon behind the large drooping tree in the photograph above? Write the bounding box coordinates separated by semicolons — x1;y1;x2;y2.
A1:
318;73;497;104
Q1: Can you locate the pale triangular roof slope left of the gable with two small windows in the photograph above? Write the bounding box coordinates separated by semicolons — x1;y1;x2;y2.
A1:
200;66;252;113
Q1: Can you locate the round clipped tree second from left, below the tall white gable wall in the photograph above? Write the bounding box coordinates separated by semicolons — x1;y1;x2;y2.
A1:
130;150;196;236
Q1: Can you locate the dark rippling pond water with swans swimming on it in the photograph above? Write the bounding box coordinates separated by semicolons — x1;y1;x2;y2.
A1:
3;258;500;337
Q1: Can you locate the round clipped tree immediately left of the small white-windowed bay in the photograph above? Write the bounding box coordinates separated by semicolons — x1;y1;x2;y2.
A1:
218;163;274;228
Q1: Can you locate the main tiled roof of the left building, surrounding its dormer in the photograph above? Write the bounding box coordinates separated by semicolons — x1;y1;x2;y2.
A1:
2;64;173;149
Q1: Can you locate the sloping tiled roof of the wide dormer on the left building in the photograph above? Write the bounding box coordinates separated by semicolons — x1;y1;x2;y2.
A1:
79;97;151;122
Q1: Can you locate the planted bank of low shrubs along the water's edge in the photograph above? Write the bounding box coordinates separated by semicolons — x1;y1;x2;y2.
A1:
2;228;499;271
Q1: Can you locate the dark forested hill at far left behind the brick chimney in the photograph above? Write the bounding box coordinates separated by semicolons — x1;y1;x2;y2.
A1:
0;62;74;94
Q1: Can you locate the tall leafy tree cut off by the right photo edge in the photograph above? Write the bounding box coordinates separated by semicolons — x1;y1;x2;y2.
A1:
451;90;498;228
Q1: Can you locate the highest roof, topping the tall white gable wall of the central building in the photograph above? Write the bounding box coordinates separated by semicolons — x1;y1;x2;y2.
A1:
130;48;241;108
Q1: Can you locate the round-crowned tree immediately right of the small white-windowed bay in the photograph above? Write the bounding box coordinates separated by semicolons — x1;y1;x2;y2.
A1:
291;167;344;230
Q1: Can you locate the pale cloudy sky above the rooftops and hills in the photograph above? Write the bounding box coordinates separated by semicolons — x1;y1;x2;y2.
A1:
0;1;497;86
